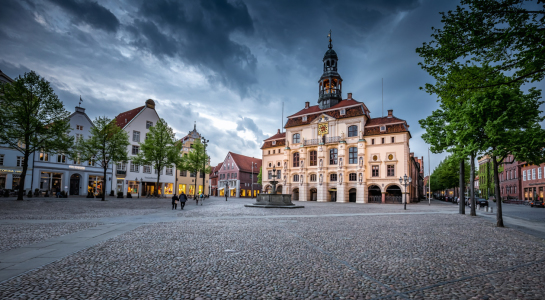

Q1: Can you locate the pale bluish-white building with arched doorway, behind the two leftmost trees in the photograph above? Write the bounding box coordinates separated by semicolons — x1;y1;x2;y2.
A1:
29;107;113;195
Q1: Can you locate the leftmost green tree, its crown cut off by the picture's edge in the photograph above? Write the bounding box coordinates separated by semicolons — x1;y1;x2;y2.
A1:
0;71;74;200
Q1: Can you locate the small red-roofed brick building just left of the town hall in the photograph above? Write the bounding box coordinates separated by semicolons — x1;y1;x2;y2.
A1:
218;152;262;198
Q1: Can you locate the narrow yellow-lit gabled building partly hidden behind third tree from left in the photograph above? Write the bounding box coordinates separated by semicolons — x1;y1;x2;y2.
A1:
176;126;210;195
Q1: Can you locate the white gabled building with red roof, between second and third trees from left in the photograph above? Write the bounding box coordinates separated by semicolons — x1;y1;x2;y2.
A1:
115;99;176;197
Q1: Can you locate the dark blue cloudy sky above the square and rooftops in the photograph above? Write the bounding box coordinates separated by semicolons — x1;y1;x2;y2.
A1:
0;0;540;173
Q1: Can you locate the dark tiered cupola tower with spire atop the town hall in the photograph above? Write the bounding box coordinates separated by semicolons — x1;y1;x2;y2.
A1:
318;30;343;109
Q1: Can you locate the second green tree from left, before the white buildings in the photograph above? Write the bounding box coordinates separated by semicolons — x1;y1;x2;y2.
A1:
77;116;130;201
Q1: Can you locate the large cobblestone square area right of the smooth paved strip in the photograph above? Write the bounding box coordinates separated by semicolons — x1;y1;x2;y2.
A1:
0;198;545;299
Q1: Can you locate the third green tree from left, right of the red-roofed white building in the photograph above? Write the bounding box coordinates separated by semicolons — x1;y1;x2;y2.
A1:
132;119;182;196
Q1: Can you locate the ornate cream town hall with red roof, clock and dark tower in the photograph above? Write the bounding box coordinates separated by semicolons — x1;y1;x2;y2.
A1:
261;43;411;203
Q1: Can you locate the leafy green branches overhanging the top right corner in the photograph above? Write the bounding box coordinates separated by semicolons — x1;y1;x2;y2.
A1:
416;0;545;90
